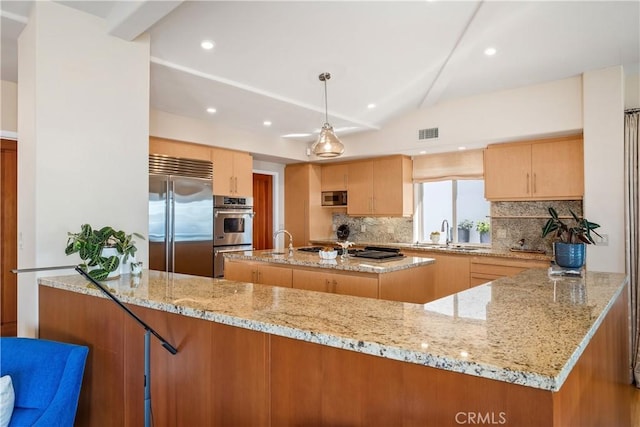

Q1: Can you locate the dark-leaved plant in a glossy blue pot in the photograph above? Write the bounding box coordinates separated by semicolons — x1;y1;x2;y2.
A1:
542;207;602;268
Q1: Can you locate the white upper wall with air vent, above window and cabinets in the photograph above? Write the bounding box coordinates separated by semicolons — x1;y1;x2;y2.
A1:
341;76;582;156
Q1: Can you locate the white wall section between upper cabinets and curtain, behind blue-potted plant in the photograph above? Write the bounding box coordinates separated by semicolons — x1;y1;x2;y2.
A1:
583;67;625;273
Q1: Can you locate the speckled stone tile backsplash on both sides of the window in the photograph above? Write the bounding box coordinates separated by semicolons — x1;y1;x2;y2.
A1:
332;200;582;254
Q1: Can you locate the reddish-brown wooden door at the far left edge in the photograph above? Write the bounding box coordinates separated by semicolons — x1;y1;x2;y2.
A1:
0;139;18;336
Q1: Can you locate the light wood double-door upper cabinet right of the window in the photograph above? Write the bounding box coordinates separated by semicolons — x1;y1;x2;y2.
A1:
484;134;584;200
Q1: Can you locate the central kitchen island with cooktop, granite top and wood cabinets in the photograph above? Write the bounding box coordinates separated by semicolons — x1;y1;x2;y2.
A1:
224;248;436;303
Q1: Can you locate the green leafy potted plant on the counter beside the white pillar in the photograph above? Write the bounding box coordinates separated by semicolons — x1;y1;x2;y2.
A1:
65;224;144;280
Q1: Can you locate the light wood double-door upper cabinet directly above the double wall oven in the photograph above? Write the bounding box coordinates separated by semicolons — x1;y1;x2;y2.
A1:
211;148;253;197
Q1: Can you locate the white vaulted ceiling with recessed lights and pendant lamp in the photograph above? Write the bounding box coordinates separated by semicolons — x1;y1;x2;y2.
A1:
0;0;640;155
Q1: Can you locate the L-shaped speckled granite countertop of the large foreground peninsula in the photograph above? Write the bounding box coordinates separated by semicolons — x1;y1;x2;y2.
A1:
39;269;627;391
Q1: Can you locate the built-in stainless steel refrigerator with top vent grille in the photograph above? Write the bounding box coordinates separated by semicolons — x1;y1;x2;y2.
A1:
149;154;213;277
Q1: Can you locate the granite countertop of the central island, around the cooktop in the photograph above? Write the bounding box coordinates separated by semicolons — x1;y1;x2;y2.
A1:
224;249;435;274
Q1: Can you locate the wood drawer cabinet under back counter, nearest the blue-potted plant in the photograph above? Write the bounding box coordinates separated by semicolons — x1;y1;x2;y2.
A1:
469;256;549;286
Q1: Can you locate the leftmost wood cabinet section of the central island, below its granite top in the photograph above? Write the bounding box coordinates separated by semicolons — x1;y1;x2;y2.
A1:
224;259;292;288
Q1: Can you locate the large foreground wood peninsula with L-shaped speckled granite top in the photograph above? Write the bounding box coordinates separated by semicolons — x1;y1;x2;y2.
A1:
39;269;630;426
